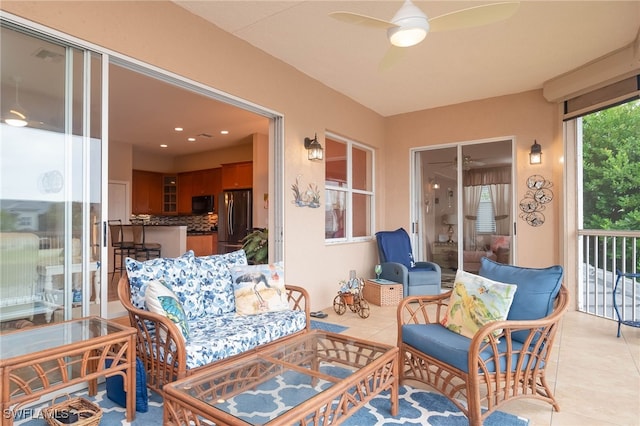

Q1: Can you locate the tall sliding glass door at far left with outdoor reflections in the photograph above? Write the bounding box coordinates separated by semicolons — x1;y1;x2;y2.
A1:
0;21;103;332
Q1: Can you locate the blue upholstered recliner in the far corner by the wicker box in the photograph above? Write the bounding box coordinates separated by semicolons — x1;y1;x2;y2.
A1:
376;228;441;297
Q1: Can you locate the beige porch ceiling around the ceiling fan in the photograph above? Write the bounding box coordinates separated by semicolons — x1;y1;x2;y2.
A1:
175;0;640;116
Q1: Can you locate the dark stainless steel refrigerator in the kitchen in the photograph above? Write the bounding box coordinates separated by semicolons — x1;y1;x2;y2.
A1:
218;189;253;254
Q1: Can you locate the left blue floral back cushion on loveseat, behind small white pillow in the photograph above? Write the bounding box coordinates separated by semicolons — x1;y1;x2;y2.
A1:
125;250;203;320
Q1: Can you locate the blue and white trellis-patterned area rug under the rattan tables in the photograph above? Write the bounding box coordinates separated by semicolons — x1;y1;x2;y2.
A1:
14;384;529;426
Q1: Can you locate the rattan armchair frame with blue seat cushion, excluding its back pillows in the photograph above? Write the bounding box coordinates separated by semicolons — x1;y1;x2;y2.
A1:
397;261;569;426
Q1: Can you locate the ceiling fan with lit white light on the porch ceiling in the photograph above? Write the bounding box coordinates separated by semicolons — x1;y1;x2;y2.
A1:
329;0;520;47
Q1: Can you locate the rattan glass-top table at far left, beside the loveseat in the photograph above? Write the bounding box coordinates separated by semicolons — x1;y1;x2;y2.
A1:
0;317;136;426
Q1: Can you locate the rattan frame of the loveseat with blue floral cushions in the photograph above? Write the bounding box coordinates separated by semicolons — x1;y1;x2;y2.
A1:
118;274;310;395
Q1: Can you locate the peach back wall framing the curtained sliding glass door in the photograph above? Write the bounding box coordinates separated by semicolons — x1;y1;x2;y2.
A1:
383;90;562;267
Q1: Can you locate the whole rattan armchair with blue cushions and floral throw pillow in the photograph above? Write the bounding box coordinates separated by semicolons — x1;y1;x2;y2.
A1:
397;257;569;426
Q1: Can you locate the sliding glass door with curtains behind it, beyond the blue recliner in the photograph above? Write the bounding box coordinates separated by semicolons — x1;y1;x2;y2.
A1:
414;139;514;274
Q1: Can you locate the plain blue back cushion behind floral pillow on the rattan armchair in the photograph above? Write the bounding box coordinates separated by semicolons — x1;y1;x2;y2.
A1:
478;257;563;341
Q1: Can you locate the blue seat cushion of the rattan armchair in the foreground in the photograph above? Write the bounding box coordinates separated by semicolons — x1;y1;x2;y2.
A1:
402;324;530;373
